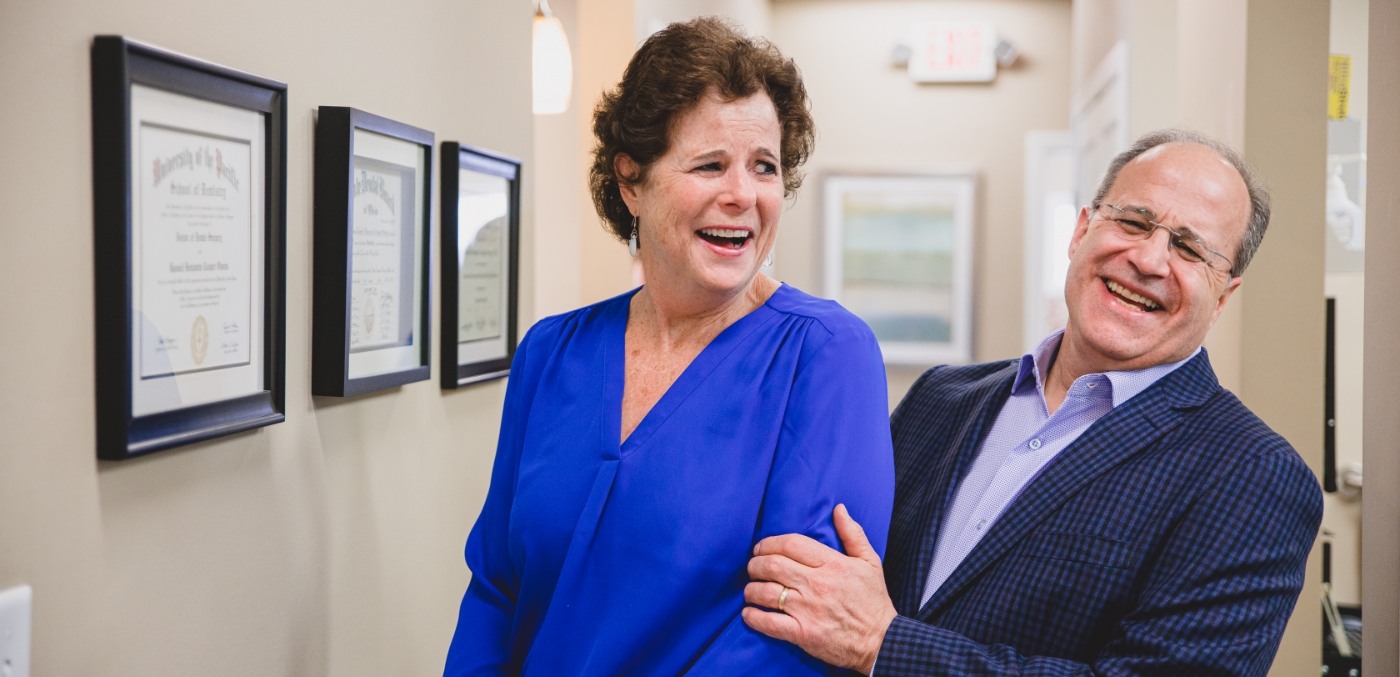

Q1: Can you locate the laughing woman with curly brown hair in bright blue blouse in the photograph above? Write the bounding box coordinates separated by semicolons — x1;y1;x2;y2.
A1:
447;18;893;676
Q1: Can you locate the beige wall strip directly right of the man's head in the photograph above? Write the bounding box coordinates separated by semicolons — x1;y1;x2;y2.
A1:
1238;0;1327;677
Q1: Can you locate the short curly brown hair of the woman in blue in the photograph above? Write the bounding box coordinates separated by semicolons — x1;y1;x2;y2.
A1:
588;17;815;242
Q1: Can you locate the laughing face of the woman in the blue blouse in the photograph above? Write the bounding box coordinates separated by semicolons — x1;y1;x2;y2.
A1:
616;92;783;302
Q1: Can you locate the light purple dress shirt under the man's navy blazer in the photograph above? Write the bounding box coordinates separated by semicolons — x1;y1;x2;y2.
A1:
920;330;1200;606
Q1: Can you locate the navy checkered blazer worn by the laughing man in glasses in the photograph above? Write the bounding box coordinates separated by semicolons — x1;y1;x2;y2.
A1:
875;351;1322;677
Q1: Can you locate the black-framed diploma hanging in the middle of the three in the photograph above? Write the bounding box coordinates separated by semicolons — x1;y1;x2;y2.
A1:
311;106;433;397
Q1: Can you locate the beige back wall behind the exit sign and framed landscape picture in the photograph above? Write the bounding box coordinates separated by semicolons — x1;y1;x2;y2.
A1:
773;0;1070;404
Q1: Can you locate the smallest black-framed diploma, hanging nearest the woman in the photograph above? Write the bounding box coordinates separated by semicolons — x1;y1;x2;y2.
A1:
440;141;521;389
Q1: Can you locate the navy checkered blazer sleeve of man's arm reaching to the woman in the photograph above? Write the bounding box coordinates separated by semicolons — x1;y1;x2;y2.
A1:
874;439;1322;676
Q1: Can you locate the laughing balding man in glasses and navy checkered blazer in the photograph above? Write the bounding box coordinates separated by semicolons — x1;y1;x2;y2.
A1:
743;130;1322;676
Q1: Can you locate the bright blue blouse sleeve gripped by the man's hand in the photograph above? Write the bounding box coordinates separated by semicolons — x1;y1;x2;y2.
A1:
690;322;895;676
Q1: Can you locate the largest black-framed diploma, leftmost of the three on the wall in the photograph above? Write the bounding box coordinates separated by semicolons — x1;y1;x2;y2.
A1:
91;35;287;460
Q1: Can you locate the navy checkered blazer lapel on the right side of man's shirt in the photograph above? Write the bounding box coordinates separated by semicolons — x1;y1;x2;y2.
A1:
918;350;1219;620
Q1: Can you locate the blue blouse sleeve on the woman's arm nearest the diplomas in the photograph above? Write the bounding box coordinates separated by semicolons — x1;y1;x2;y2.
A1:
442;329;543;677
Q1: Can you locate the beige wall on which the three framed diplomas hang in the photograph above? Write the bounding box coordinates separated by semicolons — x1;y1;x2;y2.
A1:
0;0;533;677
